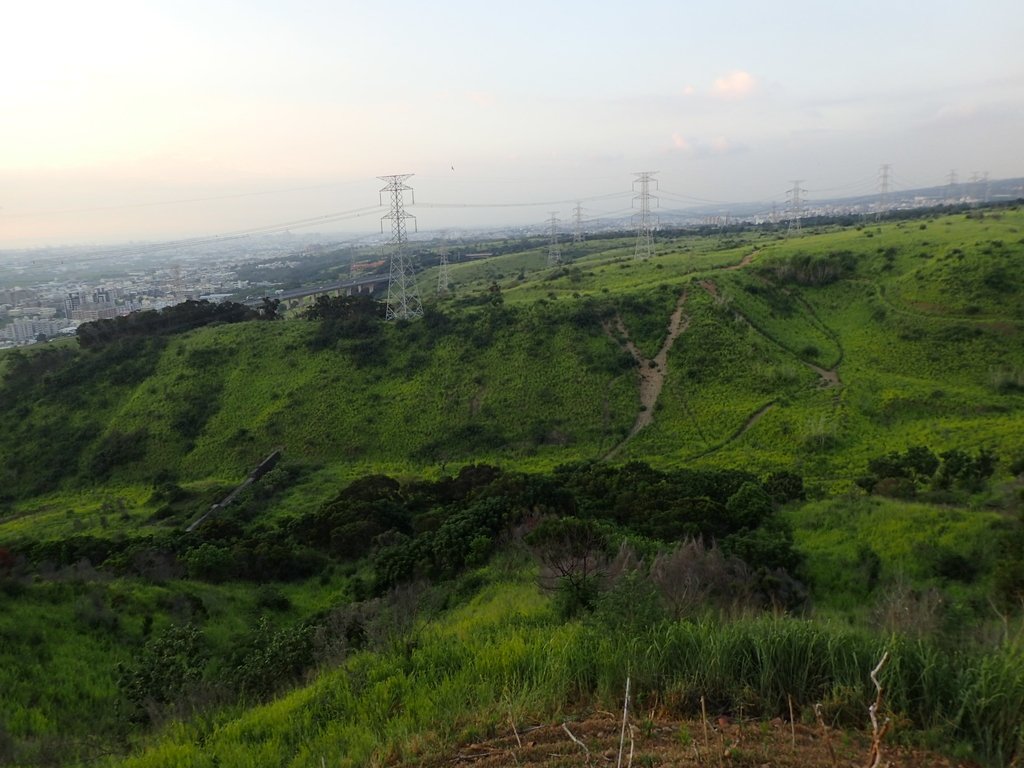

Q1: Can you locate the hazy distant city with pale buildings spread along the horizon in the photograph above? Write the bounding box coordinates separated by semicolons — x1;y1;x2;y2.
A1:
0;178;1024;348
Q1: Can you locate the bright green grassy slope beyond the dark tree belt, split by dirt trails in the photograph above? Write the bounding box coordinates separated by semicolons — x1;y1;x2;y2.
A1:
6;212;1024;507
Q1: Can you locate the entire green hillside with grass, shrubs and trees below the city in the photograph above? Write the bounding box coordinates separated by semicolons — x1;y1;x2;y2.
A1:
0;207;1024;766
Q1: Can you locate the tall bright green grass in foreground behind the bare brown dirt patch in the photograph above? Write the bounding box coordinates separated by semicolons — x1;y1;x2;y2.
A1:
101;578;1024;768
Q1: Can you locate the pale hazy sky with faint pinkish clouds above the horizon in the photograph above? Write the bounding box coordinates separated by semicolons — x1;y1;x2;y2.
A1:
0;0;1024;249
